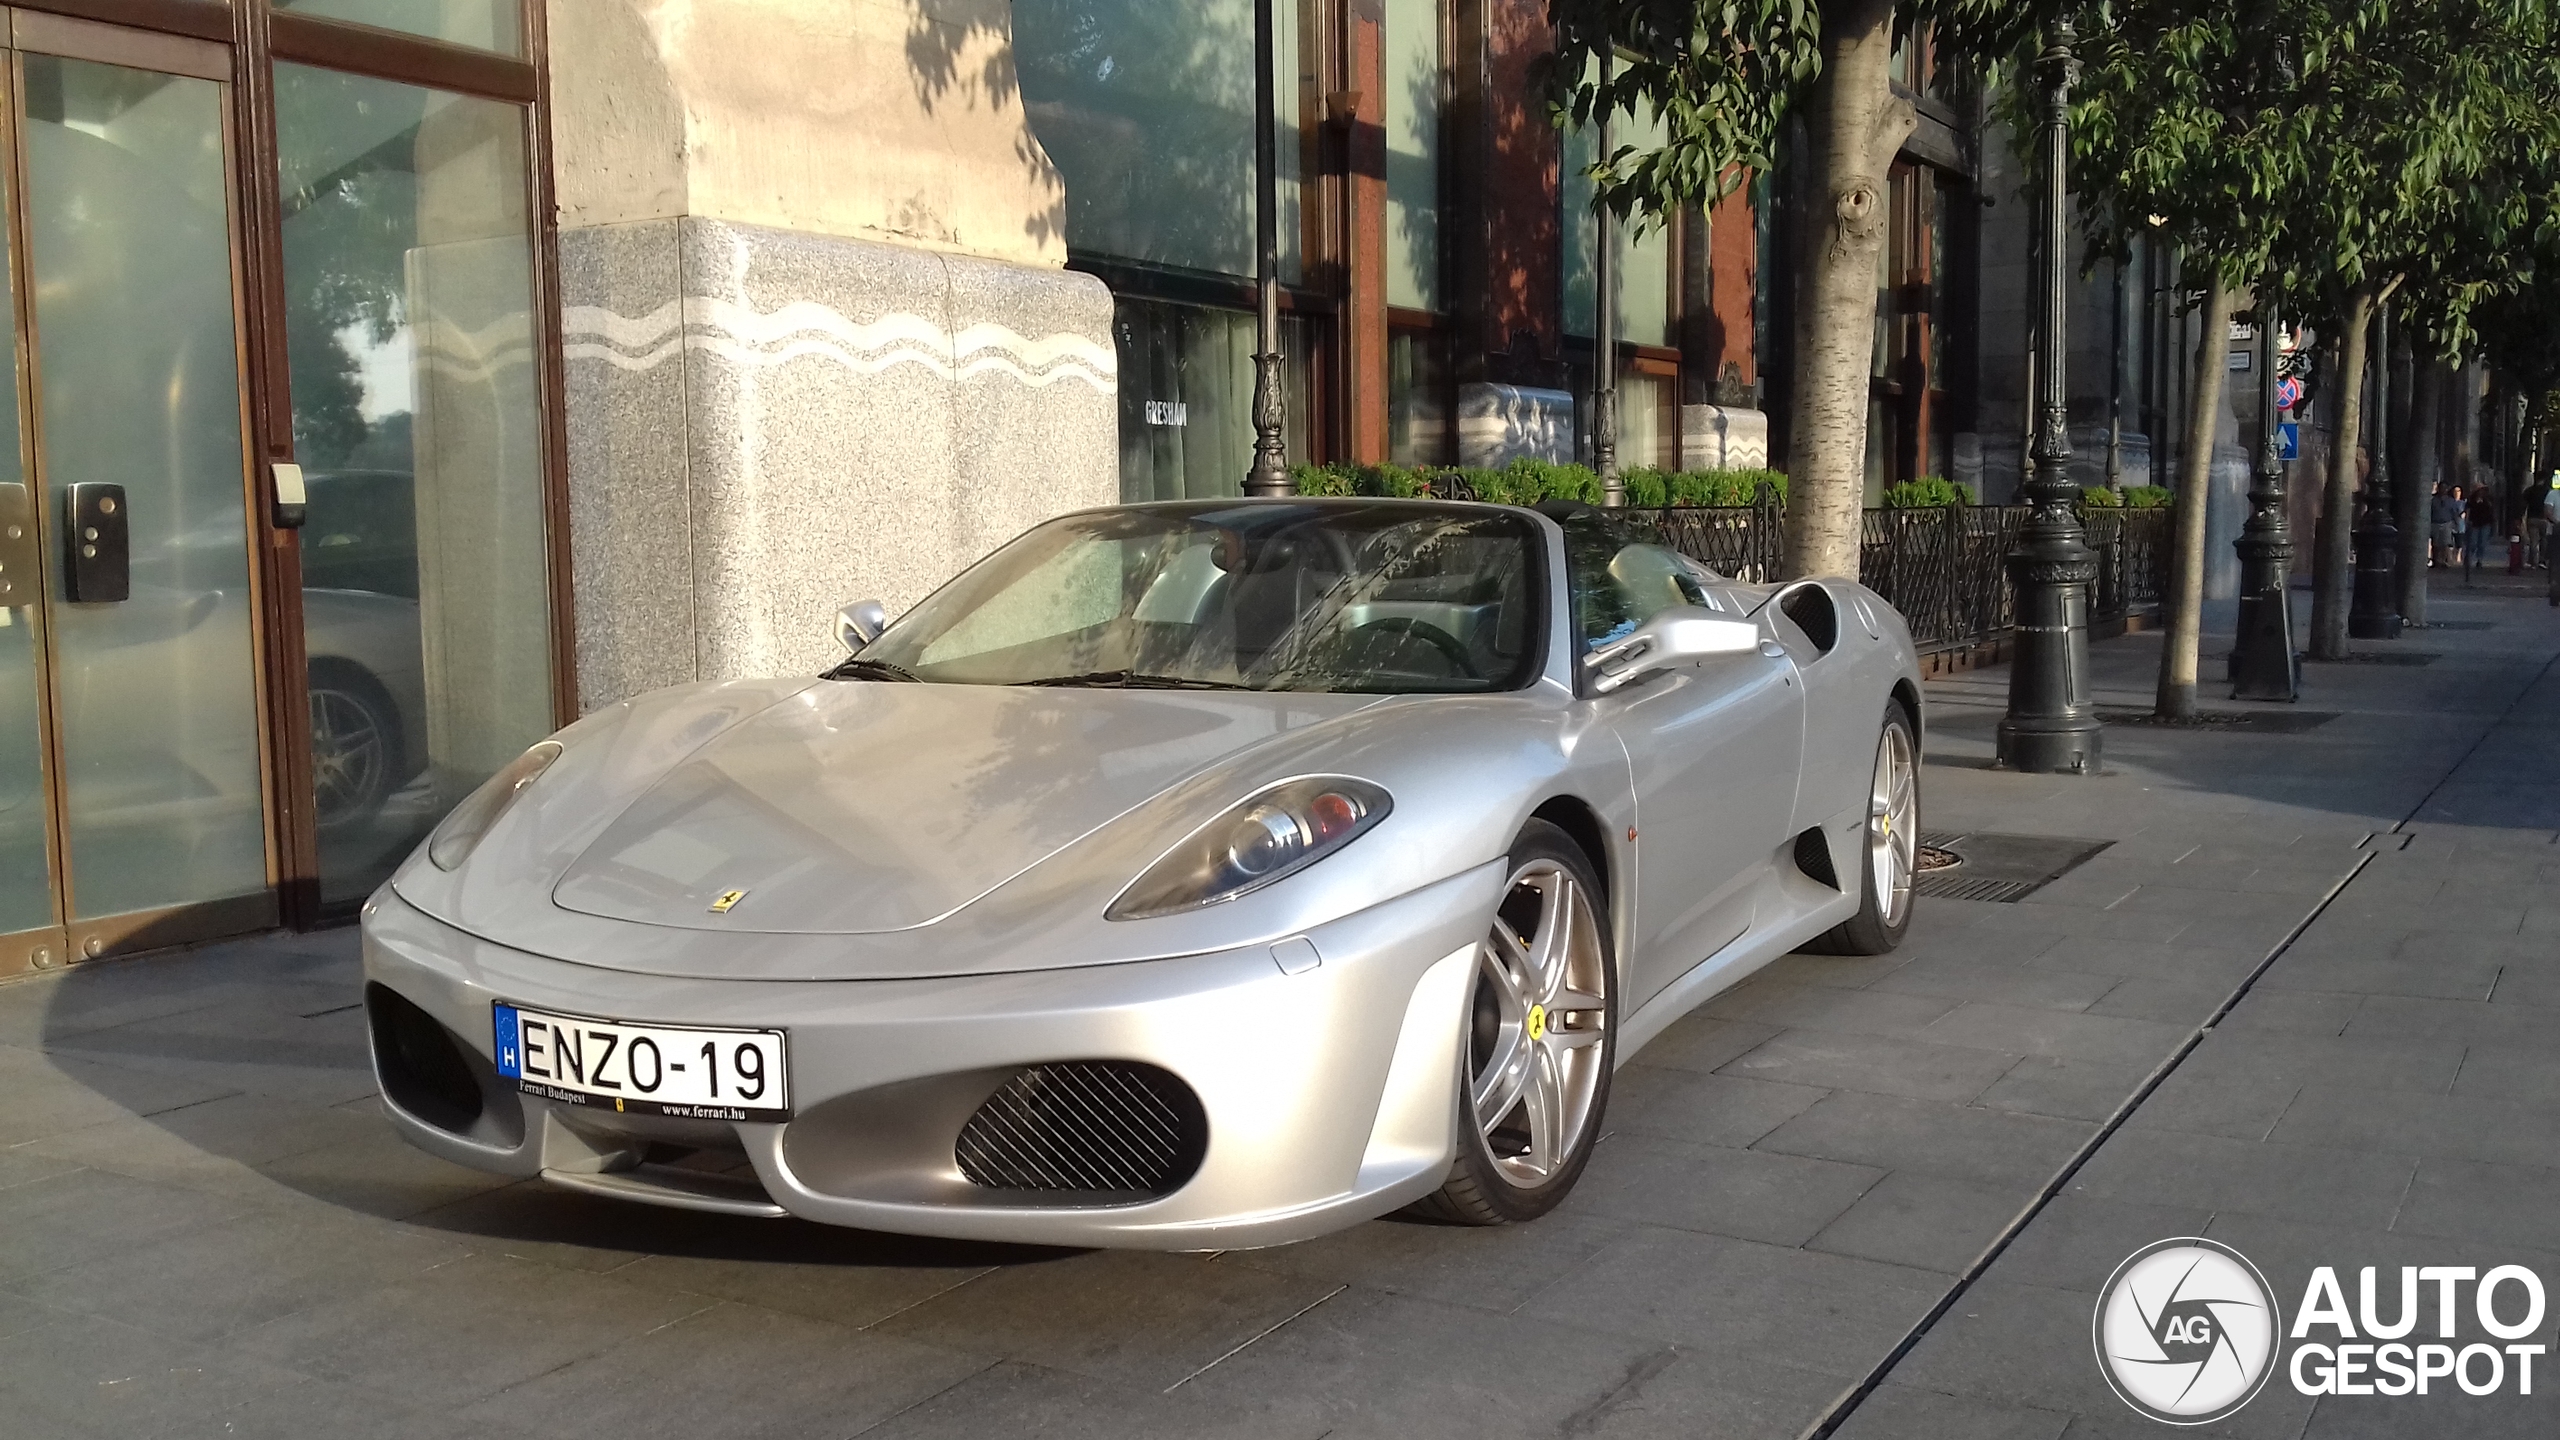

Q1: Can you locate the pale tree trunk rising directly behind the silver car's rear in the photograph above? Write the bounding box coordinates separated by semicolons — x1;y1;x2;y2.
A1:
1784;0;1917;577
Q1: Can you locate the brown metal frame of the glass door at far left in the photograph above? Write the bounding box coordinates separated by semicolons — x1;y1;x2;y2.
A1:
0;8;282;976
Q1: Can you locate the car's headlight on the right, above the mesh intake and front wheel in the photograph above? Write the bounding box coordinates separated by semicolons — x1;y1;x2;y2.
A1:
1103;776;1395;920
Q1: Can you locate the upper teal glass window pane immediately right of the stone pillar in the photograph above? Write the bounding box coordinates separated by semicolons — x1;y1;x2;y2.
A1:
1014;0;1311;282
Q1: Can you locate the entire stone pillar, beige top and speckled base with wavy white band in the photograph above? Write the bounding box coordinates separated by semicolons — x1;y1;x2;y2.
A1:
550;0;1119;707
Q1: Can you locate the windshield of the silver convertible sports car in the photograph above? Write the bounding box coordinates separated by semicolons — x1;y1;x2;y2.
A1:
863;500;1539;694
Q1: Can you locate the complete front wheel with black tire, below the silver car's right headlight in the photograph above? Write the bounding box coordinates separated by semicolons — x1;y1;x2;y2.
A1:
1413;820;1618;1225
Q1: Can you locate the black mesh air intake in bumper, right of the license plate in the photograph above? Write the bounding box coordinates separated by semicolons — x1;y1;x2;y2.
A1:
952;1061;1208;1197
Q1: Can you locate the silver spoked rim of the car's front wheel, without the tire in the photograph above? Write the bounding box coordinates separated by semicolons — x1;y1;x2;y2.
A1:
1467;858;1608;1189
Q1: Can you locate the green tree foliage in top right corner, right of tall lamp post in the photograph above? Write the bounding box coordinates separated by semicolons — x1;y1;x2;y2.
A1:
2048;0;2560;356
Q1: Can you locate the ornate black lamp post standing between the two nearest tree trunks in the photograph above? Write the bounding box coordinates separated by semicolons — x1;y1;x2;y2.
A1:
1999;20;2102;774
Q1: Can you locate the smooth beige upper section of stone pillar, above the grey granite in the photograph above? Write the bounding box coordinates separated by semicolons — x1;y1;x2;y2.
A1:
550;0;1065;266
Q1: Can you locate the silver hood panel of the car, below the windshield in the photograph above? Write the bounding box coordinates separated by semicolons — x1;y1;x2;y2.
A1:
553;682;1375;935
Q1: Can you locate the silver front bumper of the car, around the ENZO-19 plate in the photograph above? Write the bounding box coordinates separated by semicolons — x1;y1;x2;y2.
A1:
364;863;1503;1250
